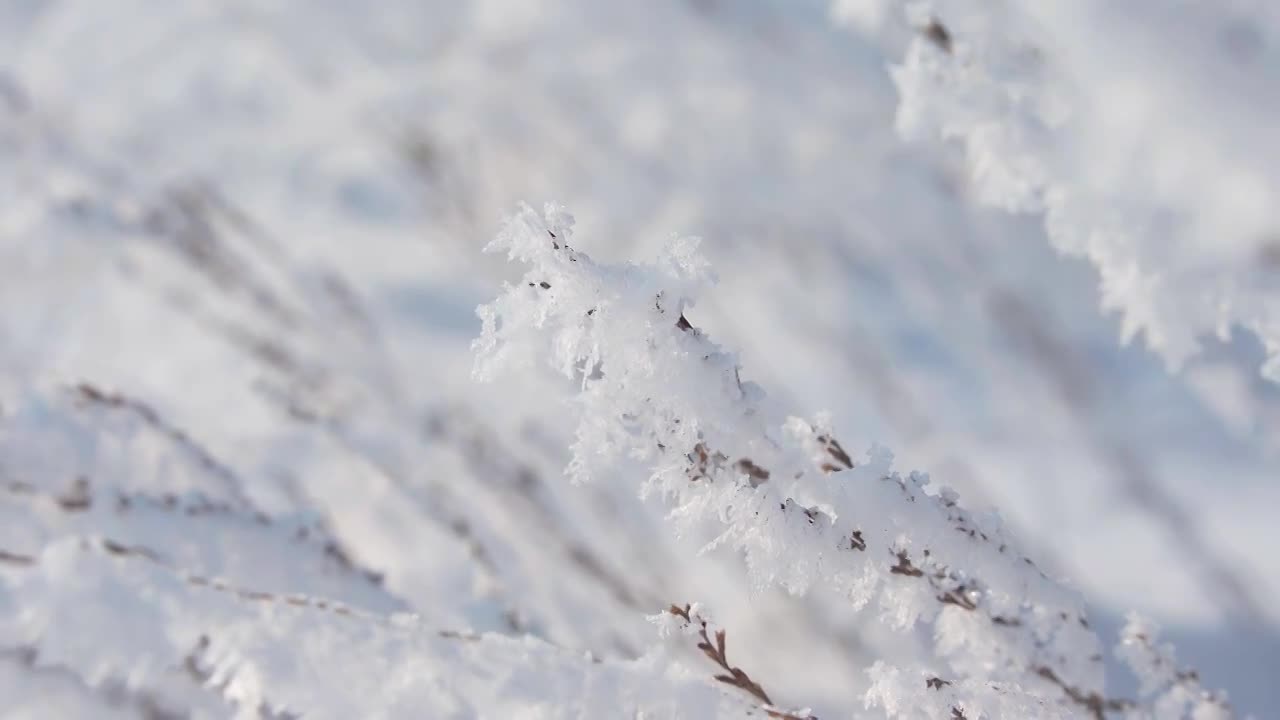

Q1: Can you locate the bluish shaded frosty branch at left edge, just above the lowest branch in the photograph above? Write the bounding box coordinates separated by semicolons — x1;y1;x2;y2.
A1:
0;383;403;611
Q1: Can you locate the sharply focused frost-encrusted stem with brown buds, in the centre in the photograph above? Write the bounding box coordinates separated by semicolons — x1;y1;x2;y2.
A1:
475;206;1228;720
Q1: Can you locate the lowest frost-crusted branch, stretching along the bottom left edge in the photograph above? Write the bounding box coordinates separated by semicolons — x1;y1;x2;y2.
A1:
0;538;742;719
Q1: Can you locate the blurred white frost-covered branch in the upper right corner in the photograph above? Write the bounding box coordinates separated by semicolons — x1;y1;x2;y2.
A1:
875;0;1280;380
